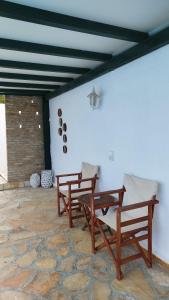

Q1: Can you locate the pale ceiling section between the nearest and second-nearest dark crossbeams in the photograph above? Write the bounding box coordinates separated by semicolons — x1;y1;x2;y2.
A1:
0;17;134;54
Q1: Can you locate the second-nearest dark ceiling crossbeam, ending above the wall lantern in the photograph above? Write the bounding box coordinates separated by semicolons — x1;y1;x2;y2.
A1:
0;38;112;61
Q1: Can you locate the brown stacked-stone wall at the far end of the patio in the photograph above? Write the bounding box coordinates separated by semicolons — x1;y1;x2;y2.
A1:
6;96;44;182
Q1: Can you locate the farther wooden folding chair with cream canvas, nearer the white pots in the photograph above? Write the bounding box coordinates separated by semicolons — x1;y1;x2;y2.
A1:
56;163;98;227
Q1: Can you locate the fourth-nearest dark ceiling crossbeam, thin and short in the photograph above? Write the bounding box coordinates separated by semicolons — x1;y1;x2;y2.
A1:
0;72;72;82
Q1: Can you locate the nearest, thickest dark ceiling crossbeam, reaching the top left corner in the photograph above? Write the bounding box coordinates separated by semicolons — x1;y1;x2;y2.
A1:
0;0;148;42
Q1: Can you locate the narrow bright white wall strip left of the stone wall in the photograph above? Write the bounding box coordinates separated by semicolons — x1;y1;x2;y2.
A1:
0;104;8;179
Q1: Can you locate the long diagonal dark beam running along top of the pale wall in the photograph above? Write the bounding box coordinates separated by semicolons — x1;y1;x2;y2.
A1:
48;27;169;99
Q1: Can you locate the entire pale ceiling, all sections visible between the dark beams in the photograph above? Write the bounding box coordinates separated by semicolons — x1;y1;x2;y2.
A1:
0;0;169;93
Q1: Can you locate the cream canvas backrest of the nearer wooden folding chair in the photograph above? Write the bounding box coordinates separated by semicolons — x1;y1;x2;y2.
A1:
123;174;158;217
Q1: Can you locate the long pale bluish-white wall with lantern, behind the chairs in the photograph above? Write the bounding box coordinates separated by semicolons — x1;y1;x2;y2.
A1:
50;46;169;262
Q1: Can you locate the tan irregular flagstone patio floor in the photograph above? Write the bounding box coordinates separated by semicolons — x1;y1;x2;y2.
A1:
0;188;169;300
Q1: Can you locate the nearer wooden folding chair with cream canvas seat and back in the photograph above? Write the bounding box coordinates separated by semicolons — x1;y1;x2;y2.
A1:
91;175;159;280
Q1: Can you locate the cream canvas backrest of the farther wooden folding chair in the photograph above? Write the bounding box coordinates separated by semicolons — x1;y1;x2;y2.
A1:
81;162;99;188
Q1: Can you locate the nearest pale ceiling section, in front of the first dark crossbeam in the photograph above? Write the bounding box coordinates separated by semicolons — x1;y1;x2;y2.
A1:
7;0;169;31
